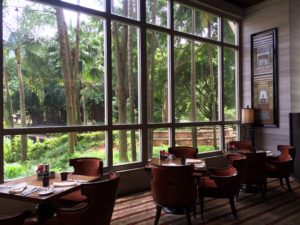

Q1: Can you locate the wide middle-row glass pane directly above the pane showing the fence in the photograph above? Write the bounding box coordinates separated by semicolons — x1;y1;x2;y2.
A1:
174;37;218;122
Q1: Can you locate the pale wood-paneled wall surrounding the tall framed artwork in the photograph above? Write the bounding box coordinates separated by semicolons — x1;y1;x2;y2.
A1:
242;0;291;150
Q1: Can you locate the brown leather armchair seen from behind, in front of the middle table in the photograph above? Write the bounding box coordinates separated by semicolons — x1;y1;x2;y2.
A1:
151;165;197;225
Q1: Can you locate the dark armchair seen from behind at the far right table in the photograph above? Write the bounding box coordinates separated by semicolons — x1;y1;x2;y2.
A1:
237;152;267;198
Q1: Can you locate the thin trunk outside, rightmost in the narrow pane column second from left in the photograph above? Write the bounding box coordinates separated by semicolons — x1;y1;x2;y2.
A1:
127;1;136;162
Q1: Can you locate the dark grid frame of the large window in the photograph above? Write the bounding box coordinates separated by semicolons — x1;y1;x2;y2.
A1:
0;0;242;183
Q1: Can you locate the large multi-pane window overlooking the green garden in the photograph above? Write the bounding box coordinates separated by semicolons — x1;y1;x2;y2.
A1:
0;0;240;181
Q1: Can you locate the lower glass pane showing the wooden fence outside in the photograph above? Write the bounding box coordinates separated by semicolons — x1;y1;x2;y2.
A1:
175;126;220;152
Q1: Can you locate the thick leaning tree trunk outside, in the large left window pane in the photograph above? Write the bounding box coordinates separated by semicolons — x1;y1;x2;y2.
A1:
56;8;76;154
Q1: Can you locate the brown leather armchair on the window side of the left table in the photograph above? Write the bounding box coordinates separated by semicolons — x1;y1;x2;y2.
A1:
56;157;103;205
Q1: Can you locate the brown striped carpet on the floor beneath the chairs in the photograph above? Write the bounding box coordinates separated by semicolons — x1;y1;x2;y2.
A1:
111;178;300;225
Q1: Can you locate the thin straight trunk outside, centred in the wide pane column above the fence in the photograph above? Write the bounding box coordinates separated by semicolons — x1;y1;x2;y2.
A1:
191;10;197;147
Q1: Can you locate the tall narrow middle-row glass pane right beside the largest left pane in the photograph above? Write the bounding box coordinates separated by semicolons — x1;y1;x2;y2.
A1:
112;22;139;124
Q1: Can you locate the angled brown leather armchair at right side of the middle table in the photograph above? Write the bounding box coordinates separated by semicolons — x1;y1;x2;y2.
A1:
199;167;240;218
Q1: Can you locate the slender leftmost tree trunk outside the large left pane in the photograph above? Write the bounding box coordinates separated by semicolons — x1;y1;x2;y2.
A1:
15;48;27;162
